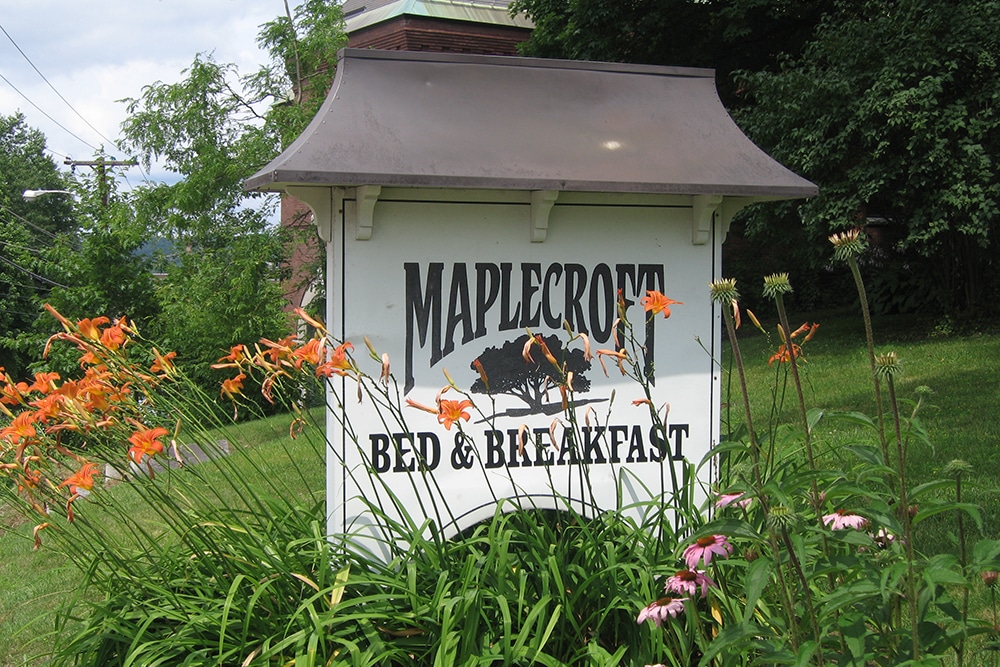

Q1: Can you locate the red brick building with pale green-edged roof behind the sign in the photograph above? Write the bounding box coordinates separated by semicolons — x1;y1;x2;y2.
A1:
281;0;532;307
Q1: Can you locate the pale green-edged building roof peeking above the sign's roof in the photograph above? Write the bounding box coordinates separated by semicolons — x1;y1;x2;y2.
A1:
341;0;533;34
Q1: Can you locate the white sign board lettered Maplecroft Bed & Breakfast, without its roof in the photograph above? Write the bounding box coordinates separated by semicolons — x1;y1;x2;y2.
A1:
328;189;721;552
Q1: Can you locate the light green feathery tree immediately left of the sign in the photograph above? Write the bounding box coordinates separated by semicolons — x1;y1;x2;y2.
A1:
114;0;344;400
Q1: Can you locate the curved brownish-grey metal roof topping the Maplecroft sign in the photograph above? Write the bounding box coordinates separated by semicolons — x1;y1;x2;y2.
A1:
245;49;817;199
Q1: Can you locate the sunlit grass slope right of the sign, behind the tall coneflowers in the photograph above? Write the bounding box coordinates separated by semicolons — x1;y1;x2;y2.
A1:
723;312;1000;552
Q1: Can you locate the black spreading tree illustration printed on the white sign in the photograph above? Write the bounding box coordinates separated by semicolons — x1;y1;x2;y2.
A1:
471;334;590;415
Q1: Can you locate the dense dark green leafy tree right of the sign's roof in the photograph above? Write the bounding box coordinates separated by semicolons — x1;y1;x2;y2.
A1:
736;0;1000;313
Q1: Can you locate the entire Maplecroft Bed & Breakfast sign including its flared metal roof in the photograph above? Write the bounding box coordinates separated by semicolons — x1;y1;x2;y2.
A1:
248;51;815;556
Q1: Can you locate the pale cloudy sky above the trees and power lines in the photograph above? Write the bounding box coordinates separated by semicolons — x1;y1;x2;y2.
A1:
0;0;297;188
